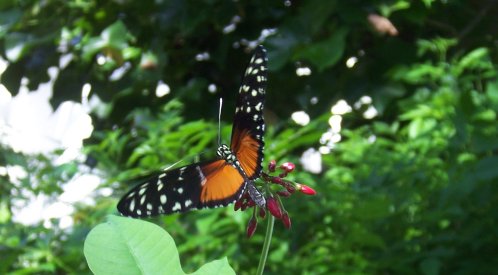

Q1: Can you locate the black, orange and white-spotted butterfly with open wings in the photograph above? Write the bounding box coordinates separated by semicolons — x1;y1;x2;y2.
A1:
117;46;267;218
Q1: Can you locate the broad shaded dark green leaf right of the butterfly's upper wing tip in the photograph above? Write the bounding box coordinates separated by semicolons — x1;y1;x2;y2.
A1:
298;28;348;72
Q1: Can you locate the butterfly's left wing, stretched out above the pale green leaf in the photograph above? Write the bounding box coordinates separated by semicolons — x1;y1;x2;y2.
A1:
118;160;245;218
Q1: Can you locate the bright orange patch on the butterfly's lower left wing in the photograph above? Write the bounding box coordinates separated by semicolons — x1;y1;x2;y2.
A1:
200;160;244;204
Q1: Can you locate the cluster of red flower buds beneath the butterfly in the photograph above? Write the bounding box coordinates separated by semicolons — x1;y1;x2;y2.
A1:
234;160;316;238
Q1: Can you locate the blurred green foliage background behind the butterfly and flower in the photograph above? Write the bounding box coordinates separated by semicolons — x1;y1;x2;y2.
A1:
0;0;498;274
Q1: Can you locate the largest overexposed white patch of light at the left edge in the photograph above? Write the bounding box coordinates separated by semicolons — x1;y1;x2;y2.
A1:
0;68;93;154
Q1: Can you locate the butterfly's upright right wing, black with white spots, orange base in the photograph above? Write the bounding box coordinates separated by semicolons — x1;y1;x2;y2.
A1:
230;46;267;179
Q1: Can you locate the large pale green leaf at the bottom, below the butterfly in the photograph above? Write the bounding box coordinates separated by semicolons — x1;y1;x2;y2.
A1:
84;216;235;274
